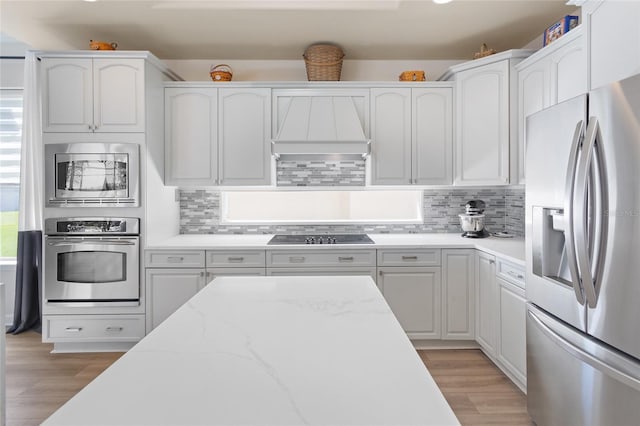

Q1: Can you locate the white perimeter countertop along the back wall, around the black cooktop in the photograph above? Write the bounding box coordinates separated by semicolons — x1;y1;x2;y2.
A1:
147;233;525;266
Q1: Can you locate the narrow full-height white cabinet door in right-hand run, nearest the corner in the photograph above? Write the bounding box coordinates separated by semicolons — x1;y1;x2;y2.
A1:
476;252;498;357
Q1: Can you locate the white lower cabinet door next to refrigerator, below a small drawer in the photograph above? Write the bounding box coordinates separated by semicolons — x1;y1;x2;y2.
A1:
497;278;527;387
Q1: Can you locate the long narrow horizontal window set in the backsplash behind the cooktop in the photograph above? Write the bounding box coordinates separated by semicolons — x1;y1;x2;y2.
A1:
220;190;423;224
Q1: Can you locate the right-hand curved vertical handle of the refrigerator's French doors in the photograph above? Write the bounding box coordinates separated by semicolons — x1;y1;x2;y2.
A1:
572;118;598;308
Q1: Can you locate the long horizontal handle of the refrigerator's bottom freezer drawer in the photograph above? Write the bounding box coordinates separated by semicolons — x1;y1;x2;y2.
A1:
527;308;640;391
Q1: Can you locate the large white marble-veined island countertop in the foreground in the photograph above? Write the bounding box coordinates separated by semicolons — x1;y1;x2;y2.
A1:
44;276;459;426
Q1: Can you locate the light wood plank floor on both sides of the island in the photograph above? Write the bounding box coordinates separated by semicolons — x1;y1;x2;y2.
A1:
6;332;531;426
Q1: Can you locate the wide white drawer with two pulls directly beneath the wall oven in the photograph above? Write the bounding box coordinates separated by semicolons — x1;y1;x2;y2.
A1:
43;315;145;342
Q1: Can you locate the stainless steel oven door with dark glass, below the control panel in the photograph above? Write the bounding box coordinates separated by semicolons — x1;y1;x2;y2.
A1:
44;237;140;306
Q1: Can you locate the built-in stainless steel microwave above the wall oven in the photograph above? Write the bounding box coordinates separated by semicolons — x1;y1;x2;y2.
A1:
45;142;140;207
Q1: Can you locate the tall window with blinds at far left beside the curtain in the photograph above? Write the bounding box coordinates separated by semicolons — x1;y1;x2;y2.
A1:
0;89;22;258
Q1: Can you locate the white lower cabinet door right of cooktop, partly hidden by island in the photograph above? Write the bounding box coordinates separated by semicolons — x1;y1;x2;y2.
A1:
378;267;441;339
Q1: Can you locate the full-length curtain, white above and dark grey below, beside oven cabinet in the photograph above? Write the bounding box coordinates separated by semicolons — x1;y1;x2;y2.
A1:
9;51;44;334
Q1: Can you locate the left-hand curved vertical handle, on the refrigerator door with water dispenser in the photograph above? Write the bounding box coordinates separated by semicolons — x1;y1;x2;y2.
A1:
564;120;585;305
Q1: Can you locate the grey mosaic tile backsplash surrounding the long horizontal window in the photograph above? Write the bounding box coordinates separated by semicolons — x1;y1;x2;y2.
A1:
180;186;524;236
